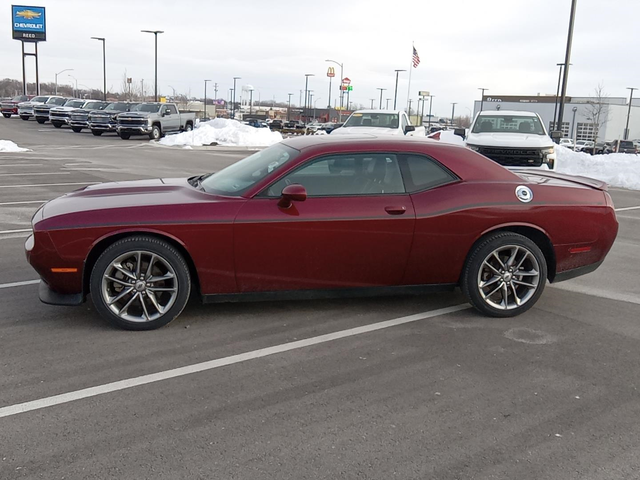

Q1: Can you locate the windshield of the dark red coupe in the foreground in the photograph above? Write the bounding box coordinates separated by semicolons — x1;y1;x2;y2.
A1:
202;143;300;196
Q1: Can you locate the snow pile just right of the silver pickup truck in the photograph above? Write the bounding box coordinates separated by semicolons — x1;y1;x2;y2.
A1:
159;118;282;147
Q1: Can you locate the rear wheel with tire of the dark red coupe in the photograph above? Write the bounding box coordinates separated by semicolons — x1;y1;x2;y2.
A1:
461;232;547;317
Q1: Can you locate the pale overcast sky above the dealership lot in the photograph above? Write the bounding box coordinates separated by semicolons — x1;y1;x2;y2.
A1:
0;0;640;115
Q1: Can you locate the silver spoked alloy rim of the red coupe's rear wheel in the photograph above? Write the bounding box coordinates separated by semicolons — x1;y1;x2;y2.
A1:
478;245;540;310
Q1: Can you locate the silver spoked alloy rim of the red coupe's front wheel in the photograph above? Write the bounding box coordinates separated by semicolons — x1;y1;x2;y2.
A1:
102;251;178;322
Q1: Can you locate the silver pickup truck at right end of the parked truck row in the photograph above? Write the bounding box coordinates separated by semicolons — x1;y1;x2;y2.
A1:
116;103;196;140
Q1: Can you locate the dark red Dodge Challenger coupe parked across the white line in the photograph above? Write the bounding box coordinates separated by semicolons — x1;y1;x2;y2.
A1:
26;136;618;330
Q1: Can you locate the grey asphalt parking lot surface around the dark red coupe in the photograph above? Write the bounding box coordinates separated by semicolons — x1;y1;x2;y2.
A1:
0;118;640;480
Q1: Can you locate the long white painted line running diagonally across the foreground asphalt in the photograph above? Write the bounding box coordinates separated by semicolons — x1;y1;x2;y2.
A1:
0;304;470;418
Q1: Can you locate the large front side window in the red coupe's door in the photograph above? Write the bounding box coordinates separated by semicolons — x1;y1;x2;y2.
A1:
266;153;405;197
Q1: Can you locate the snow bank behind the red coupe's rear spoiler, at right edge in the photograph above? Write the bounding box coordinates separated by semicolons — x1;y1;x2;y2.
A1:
556;145;640;190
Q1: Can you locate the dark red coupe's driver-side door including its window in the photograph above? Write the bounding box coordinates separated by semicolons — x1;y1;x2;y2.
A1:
234;153;415;292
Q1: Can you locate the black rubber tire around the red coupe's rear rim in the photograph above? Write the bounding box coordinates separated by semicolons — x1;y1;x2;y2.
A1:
460;232;547;317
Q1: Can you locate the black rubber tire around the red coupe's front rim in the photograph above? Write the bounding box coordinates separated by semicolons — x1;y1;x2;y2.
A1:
90;235;191;330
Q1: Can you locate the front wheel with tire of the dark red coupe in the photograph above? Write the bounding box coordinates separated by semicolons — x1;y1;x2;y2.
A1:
91;236;191;330
